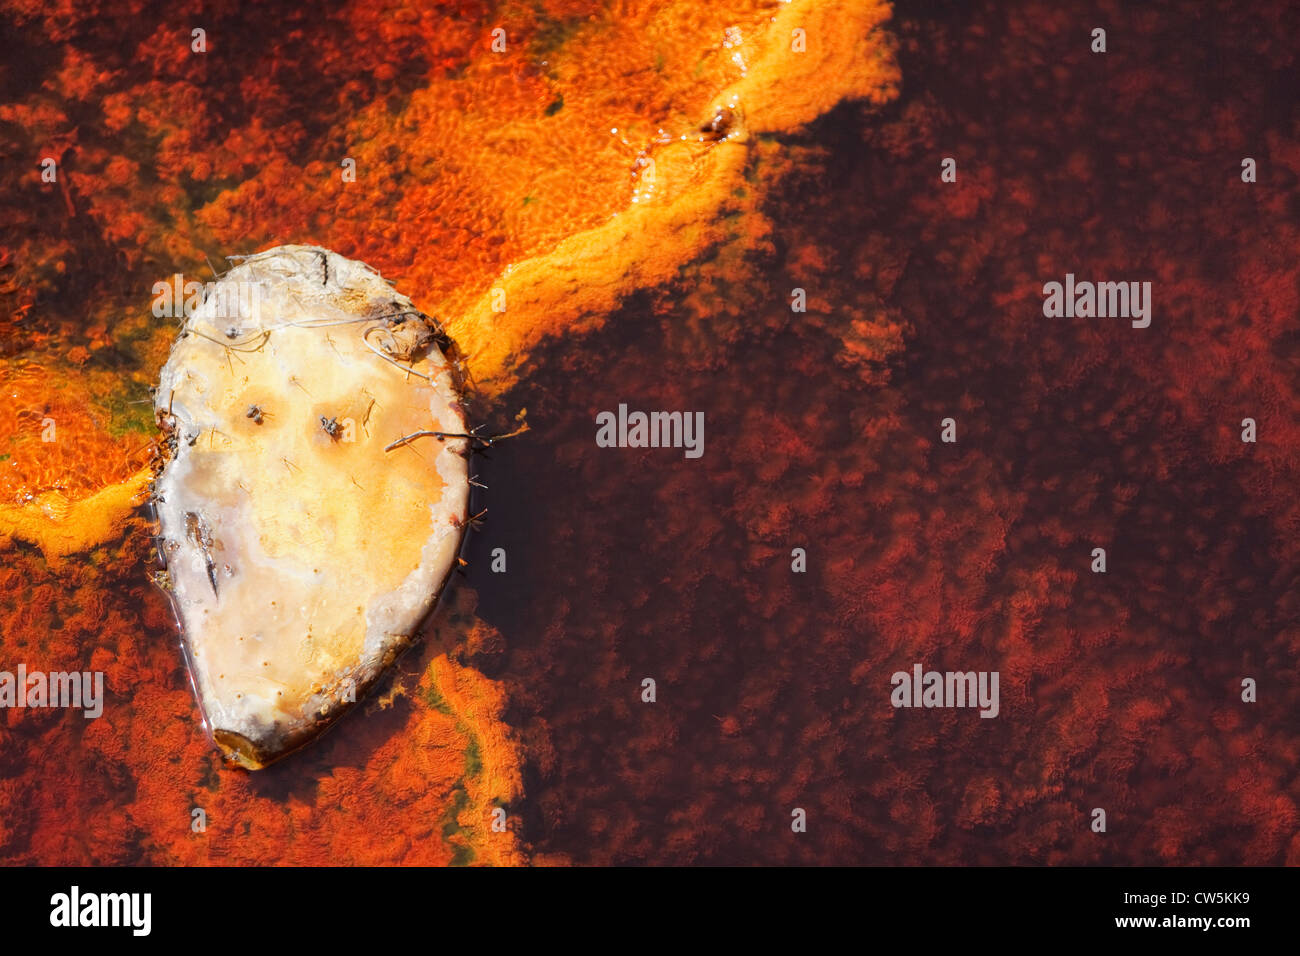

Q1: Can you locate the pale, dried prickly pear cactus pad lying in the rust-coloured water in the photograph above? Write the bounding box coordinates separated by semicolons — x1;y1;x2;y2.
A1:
155;246;469;769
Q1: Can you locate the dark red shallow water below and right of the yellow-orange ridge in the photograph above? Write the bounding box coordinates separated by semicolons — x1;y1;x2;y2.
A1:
0;3;1300;864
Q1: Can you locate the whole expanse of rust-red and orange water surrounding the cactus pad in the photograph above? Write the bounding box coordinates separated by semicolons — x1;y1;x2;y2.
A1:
0;0;1300;864
